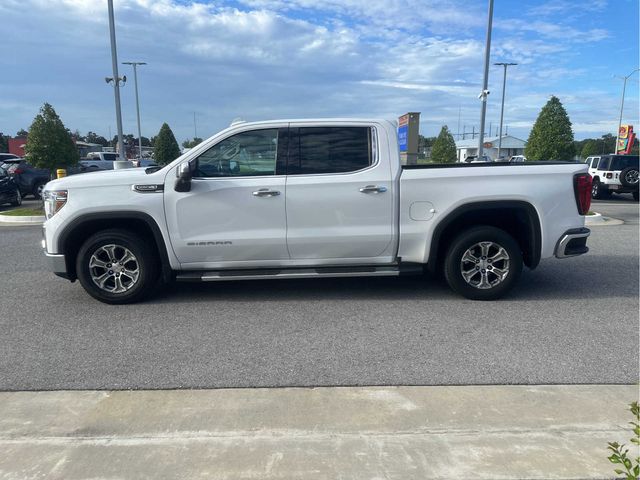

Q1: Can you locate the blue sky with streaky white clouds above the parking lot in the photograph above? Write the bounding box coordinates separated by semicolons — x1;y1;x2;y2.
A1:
0;0;640;142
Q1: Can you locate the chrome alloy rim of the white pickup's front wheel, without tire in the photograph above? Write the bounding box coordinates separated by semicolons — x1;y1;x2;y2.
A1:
89;244;140;293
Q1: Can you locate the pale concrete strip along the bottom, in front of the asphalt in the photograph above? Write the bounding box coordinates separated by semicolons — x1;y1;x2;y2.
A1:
0;385;638;480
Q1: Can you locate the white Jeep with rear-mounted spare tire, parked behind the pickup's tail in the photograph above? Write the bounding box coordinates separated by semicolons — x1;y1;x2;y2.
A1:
585;154;640;200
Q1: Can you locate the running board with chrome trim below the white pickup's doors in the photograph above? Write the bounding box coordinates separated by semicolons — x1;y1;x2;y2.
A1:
176;264;423;282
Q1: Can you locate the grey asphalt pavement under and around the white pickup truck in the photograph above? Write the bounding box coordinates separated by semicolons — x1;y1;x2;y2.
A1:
0;197;639;390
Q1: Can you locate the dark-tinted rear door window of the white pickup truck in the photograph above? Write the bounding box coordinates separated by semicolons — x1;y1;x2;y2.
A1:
287;127;373;175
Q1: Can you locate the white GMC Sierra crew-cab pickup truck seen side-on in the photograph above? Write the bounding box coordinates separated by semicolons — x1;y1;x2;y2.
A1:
43;119;591;303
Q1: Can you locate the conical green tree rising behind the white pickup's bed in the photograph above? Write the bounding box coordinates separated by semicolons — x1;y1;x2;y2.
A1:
524;96;576;161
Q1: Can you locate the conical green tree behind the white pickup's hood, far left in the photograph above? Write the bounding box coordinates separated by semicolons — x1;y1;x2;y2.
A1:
24;103;80;173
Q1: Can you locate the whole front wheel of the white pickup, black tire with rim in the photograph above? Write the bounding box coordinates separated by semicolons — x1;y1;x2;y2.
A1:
76;229;159;304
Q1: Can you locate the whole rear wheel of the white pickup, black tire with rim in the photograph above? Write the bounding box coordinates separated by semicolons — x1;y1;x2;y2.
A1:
444;226;522;300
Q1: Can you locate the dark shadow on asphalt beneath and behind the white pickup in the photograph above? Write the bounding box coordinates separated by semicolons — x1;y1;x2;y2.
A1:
147;255;638;304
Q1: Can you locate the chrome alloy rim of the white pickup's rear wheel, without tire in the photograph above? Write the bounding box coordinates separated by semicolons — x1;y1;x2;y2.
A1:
460;242;509;290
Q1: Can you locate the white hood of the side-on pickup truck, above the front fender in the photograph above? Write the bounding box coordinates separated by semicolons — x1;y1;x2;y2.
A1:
45;168;166;190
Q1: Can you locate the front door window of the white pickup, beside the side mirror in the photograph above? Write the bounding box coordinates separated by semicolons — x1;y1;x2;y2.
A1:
194;128;278;177
